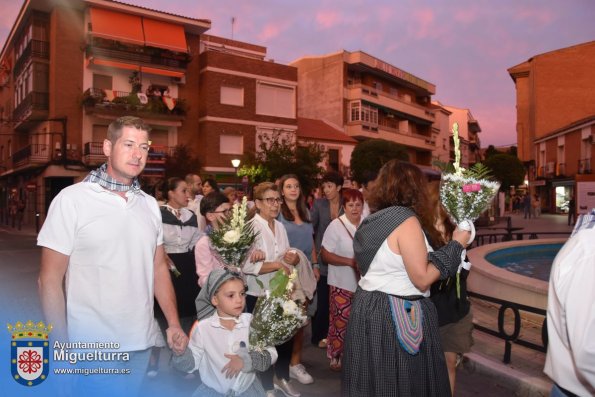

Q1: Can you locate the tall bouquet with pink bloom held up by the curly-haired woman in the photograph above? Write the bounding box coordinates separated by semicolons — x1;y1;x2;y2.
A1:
440;123;500;296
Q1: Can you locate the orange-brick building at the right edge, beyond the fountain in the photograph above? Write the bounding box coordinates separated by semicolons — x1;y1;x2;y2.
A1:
508;41;595;212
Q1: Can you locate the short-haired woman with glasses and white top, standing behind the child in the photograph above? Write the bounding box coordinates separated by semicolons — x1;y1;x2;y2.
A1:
243;182;300;397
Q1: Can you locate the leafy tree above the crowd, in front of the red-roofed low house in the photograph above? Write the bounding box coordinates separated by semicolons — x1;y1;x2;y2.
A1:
238;131;326;194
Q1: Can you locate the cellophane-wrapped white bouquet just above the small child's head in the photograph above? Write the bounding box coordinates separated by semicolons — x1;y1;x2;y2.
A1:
209;196;258;273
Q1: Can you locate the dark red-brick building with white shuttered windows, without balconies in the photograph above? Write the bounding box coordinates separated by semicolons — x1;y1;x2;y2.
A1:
196;34;298;181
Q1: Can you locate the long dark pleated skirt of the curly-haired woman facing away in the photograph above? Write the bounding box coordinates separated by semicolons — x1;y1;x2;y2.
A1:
341;288;451;397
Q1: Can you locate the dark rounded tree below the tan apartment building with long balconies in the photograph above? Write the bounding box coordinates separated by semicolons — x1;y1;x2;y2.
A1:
350;139;409;183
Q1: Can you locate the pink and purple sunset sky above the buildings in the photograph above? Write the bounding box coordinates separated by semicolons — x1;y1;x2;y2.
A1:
0;0;595;147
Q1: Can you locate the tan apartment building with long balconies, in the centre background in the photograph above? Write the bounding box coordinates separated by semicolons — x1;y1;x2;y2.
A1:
290;50;438;166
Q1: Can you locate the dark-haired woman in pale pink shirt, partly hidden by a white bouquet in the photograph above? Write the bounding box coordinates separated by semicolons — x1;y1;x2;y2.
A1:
194;192;231;288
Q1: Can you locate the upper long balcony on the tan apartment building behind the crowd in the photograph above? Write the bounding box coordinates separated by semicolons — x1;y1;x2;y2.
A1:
344;84;435;124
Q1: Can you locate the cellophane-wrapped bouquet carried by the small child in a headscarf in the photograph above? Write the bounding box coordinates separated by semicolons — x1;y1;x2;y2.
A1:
249;268;308;350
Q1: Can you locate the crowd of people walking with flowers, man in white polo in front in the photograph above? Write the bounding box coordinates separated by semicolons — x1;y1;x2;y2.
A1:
38;117;480;397
